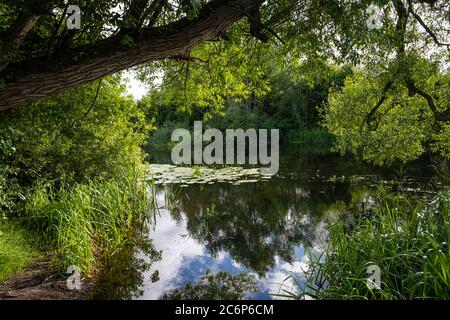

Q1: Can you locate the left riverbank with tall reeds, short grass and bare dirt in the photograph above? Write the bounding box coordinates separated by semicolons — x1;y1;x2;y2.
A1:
0;171;152;299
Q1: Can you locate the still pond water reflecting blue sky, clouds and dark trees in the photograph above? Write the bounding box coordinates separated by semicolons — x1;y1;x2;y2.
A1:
89;149;438;299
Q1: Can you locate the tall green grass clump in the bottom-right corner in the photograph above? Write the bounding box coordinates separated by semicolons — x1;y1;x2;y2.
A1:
296;192;450;299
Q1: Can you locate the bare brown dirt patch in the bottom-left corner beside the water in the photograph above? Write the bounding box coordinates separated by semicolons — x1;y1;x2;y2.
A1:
0;262;83;300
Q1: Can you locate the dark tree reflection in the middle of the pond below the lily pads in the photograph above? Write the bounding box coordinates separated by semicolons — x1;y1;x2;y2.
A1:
166;170;368;277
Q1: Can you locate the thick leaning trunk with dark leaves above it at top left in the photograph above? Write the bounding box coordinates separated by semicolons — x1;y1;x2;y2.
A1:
0;0;289;110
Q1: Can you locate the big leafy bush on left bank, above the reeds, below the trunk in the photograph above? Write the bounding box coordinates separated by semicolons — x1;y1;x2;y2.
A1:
0;77;149;186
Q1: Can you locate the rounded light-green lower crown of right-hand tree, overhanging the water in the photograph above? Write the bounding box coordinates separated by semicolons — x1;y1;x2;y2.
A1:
325;60;450;165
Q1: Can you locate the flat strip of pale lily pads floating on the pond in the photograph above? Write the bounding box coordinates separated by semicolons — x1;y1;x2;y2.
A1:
148;164;273;188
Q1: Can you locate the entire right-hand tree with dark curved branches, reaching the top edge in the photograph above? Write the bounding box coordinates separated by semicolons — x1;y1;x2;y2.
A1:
312;0;450;165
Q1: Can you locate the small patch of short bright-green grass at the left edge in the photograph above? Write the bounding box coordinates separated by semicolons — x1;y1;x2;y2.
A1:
0;219;34;282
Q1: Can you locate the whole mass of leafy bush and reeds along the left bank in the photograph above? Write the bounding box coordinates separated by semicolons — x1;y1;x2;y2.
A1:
0;77;151;277
